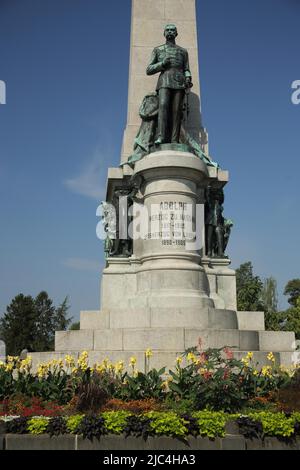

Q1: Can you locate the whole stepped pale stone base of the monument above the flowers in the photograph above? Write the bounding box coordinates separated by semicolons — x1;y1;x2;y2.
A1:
28;308;297;370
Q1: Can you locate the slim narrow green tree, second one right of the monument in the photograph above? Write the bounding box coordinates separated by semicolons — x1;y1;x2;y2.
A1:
261;277;279;330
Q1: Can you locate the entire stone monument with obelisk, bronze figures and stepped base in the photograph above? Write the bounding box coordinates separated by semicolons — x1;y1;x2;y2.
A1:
32;0;295;370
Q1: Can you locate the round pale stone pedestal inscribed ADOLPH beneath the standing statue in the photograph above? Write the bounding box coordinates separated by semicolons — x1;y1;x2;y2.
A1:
129;150;214;309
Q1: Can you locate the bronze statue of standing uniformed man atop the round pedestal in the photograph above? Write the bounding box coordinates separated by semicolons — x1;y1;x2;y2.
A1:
147;24;193;145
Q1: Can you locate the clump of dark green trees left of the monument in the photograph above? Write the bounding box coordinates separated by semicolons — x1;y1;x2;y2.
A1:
0;292;71;356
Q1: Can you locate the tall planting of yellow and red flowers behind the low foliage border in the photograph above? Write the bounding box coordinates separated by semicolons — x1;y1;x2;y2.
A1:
0;345;300;416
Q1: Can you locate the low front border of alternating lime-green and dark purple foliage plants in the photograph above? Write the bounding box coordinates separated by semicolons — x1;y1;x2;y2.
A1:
2;410;300;441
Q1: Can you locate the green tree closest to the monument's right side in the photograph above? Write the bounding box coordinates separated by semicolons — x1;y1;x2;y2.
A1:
236;261;264;312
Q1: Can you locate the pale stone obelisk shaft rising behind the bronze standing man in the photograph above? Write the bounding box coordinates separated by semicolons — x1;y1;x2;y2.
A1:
121;0;206;162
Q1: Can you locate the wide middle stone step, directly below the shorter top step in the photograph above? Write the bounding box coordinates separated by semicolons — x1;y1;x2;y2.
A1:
55;327;295;352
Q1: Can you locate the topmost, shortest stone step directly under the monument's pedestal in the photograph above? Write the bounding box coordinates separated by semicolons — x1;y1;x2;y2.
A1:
80;308;239;330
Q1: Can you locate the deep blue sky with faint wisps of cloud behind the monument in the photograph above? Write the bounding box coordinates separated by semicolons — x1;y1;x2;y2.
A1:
0;0;300;319
